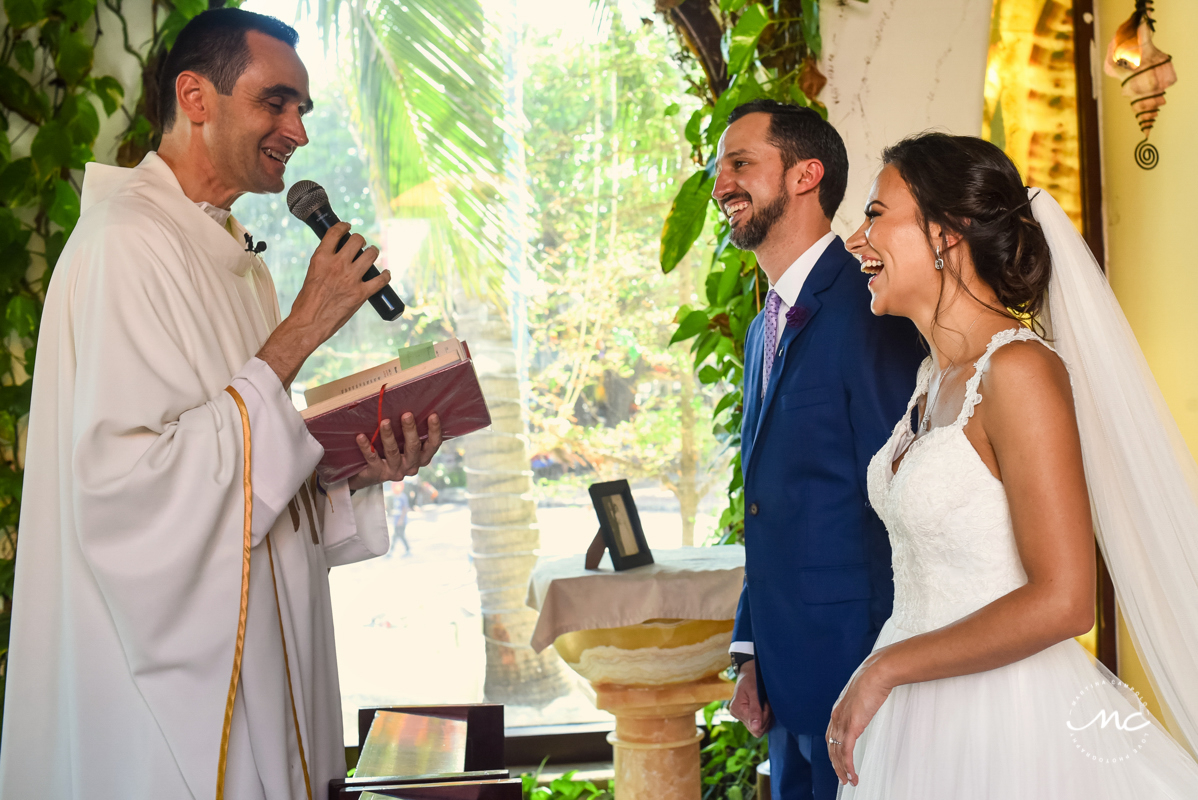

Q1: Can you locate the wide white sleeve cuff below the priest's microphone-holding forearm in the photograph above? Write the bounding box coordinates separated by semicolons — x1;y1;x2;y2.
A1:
230;358;325;545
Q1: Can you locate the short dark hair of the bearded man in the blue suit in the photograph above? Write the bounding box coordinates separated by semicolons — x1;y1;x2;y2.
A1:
728;99;848;219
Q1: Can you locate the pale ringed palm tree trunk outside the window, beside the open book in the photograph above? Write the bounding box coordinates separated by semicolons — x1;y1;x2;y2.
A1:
456;303;569;707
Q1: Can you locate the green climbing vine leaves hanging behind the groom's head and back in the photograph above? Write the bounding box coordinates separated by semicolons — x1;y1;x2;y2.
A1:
661;0;857;543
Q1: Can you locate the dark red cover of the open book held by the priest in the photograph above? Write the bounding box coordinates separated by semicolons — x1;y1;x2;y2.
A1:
304;360;491;484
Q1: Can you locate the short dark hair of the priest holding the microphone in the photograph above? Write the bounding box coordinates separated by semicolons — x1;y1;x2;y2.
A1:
157;8;300;133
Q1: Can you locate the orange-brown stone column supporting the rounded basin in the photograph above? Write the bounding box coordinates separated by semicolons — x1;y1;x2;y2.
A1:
592;677;733;800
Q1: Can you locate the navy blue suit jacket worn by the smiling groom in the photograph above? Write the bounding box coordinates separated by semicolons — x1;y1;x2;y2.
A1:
733;238;925;735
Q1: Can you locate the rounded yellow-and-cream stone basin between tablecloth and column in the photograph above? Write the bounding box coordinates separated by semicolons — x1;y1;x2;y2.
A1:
553;619;733;686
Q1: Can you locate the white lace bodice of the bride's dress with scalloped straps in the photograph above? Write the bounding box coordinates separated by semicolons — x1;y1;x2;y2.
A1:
869;328;1047;634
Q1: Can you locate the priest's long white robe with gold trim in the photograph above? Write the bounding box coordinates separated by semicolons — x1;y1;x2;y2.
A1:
0;153;388;800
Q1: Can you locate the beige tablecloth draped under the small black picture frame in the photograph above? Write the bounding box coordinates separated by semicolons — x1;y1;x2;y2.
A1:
527;545;745;653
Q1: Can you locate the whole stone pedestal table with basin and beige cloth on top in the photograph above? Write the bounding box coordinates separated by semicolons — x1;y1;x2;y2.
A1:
527;553;744;800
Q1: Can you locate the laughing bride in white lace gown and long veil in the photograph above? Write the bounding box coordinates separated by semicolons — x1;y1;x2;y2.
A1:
827;133;1198;800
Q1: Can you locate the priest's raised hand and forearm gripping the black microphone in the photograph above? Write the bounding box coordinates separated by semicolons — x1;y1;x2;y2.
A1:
258;223;391;387
